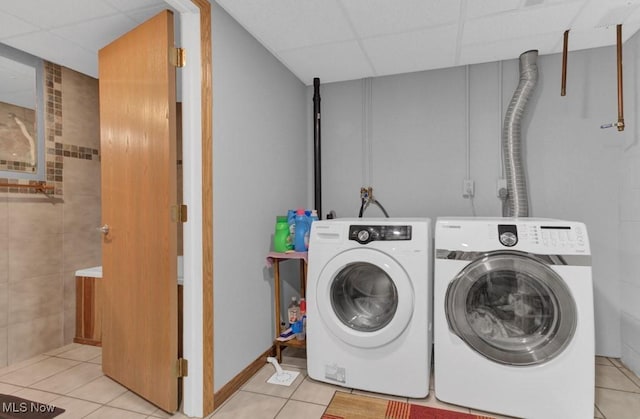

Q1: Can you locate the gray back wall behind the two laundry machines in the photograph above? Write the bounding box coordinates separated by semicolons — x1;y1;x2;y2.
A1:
316;46;624;356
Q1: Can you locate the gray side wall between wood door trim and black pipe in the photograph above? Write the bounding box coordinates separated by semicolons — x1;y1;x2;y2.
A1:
212;3;307;390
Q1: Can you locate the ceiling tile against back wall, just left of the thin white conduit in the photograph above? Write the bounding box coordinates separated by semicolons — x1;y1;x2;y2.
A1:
362;25;458;75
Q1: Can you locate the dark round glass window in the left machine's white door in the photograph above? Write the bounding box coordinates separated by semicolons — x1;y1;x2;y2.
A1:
331;262;398;332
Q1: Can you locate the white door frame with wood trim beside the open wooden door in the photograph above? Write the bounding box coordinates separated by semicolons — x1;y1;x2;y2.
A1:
165;0;214;417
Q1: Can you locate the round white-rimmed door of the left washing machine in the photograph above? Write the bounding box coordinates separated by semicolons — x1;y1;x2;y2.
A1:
316;249;414;348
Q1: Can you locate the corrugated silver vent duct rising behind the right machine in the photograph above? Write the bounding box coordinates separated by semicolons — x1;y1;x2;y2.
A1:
502;50;538;217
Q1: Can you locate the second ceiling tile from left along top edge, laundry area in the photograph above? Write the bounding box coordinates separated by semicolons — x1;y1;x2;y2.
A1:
341;0;460;38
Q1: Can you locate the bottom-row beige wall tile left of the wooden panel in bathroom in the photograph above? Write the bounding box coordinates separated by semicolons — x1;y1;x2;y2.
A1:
8;313;64;364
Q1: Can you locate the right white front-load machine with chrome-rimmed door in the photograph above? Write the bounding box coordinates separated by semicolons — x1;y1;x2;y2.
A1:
434;218;595;419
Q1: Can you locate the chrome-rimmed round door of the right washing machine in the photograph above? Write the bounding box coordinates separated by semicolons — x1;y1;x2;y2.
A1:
445;251;577;365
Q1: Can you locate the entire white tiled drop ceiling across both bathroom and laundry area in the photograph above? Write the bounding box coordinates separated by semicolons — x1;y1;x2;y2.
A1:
0;0;640;88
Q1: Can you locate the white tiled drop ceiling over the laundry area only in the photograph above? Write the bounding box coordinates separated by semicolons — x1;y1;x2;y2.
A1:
217;0;640;84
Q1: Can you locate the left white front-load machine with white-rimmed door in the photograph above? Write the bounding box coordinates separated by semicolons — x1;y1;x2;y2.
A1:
307;218;432;398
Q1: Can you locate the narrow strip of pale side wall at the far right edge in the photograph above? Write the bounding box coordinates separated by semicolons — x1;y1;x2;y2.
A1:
619;31;640;375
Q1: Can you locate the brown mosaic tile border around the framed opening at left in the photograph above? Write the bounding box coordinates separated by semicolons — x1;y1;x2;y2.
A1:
0;61;100;195
